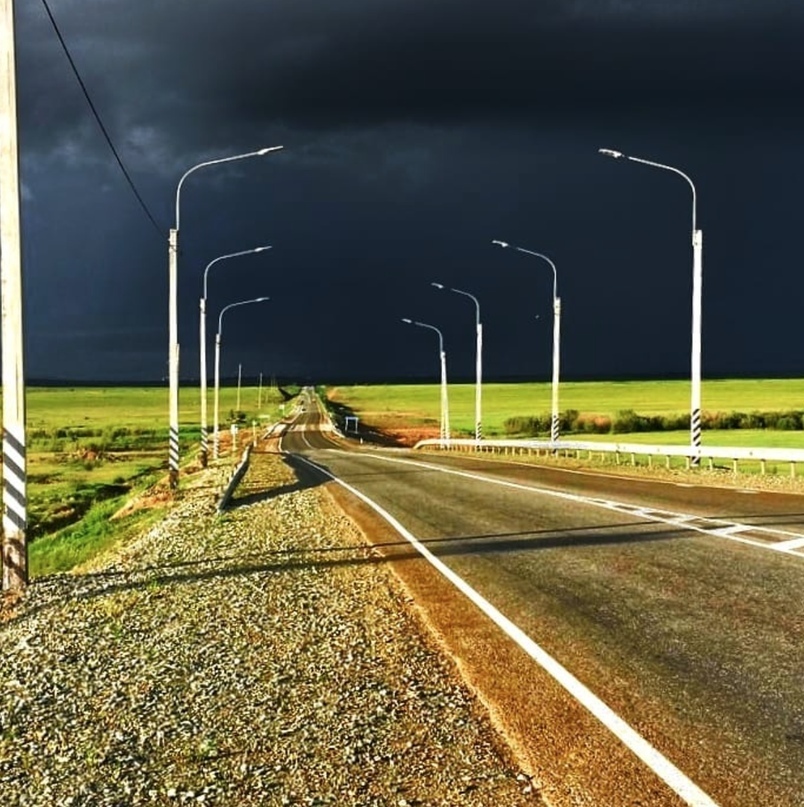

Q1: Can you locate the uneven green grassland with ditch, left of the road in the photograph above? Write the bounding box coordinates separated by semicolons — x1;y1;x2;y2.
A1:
0;387;282;576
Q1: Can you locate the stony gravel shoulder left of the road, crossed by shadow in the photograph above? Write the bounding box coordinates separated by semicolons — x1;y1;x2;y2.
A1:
0;452;543;807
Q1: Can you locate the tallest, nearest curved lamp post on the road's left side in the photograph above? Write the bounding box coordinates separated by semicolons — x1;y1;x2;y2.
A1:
168;146;283;488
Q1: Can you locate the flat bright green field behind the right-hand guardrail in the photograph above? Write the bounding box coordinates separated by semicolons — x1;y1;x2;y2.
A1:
328;379;804;446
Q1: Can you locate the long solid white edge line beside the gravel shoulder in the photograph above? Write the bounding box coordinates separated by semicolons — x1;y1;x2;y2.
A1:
295;454;718;807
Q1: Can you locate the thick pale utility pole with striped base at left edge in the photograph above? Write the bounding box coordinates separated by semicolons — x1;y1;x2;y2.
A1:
0;0;28;590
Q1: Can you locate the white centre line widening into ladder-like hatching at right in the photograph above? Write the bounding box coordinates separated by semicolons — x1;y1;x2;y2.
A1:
360;454;804;558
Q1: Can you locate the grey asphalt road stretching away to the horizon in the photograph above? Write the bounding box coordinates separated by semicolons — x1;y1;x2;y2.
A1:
283;392;804;807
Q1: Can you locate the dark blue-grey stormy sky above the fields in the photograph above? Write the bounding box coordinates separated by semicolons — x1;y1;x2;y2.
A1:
11;0;804;381
